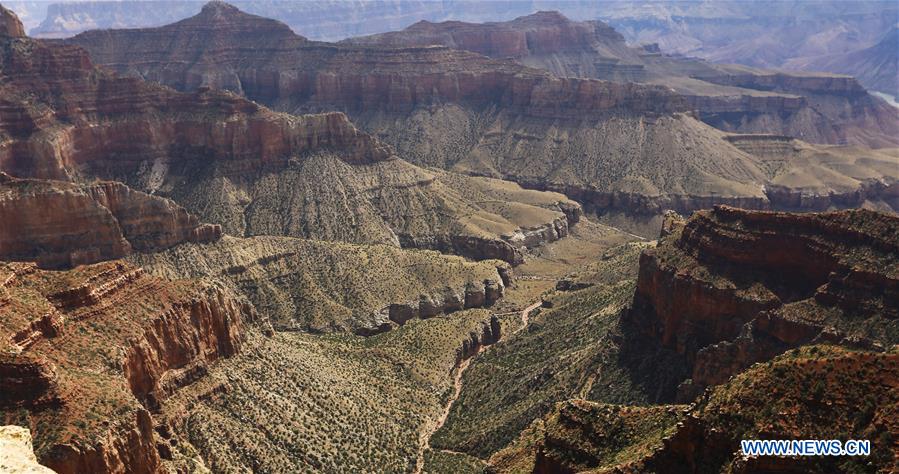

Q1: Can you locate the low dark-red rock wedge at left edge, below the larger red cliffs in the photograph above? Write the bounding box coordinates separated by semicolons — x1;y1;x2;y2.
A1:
0;173;221;267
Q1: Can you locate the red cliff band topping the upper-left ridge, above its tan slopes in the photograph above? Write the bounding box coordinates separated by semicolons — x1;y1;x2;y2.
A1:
0;10;390;183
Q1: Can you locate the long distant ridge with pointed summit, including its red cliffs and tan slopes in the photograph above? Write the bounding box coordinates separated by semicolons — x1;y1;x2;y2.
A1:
63;3;895;226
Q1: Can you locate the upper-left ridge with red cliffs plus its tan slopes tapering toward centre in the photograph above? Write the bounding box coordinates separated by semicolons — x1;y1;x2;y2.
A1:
0;3;579;263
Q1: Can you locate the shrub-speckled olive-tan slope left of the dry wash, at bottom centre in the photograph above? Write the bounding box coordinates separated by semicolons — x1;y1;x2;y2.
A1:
167;310;502;472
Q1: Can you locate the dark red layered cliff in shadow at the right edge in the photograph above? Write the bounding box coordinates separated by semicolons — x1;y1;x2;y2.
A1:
624;206;899;399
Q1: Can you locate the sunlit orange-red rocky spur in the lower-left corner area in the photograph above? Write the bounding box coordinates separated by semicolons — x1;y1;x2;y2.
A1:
0;262;256;473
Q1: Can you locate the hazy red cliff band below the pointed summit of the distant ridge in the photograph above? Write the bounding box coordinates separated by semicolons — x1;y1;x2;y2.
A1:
66;2;685;118
